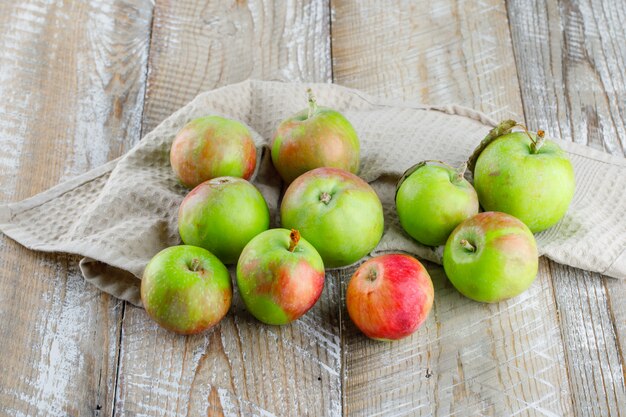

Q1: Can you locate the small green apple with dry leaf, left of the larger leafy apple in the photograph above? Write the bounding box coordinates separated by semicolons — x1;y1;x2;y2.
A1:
396;160;478;246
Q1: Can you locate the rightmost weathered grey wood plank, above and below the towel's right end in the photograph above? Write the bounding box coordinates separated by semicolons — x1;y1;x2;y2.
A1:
508;0;626;416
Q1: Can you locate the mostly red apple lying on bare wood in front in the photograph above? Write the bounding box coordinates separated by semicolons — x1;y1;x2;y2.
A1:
346;254;434;341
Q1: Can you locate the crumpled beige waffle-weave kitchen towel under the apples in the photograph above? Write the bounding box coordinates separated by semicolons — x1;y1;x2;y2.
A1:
0;81;626;305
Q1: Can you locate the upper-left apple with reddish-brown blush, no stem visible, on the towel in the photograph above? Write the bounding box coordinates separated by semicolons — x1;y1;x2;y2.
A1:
170;116;256;188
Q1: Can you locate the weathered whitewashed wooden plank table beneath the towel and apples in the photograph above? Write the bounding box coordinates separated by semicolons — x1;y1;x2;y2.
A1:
0;0;626;416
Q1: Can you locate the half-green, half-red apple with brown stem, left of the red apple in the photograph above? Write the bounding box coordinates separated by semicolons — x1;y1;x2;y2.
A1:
237;229;324;325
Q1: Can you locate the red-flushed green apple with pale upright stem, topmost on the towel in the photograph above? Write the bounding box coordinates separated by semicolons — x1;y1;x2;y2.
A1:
272;89;359;183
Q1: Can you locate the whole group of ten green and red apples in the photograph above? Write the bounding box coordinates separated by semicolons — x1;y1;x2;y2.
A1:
141;90;574;340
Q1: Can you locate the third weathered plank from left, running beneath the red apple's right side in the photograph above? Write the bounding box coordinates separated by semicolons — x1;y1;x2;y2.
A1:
332;0;571;416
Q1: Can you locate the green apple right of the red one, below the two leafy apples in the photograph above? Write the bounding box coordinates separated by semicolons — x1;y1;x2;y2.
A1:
443;212;539;303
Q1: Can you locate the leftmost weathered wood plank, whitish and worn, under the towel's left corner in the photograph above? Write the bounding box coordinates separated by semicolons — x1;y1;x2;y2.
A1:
0;0;152;416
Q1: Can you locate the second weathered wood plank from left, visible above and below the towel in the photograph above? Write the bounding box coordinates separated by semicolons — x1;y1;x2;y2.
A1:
115;1;341;416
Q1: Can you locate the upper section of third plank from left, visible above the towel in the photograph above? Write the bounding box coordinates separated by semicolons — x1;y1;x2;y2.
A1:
332;0;521;119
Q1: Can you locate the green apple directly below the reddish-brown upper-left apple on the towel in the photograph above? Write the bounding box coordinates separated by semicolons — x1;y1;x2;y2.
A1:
178;177;270;264
